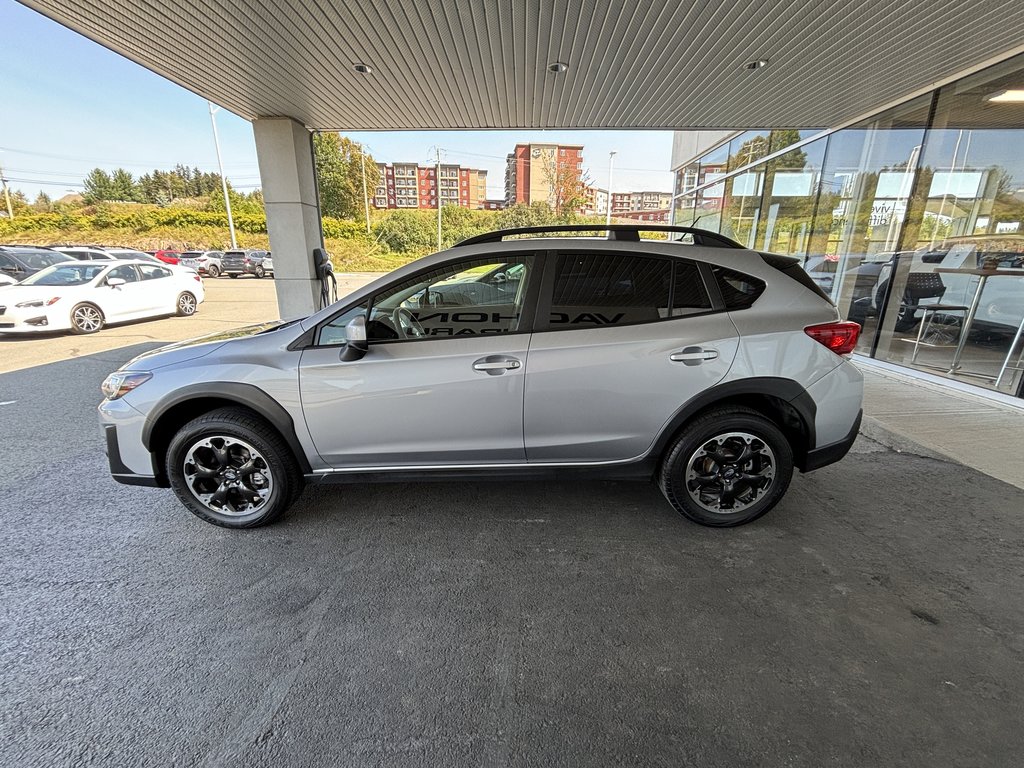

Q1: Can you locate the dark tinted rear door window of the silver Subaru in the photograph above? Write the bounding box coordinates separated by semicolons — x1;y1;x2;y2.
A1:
551;252;711;330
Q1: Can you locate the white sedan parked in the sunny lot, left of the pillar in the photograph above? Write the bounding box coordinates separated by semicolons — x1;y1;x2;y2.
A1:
0;261;205;334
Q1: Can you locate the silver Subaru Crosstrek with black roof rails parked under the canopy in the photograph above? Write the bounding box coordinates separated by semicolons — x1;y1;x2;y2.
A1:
99;225;862;528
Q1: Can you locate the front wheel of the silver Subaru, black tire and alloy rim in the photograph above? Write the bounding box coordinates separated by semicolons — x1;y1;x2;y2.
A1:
166;408;304;528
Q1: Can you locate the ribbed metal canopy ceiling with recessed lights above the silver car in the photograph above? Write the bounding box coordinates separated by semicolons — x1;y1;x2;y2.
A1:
23;0;1024;130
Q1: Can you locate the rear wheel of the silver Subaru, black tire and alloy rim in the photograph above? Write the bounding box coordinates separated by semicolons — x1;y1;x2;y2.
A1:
658;406;793;528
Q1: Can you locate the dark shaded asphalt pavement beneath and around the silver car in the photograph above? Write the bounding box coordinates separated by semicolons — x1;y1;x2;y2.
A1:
0;345;1024;768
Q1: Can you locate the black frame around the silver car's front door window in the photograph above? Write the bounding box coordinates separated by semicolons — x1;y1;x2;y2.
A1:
305;248;547;349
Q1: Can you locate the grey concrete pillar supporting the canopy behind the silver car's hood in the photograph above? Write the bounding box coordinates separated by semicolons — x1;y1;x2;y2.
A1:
253;118;324;319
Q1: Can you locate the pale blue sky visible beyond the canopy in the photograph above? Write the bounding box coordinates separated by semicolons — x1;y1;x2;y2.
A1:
0;0;672;201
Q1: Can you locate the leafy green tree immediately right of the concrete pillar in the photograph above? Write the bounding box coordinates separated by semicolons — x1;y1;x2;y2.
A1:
313;132;380;219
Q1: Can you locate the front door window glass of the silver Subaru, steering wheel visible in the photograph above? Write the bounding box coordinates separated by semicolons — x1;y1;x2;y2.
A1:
367;256;534;342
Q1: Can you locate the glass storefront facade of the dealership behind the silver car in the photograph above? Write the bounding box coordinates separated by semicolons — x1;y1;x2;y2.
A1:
673;56;1024;396
